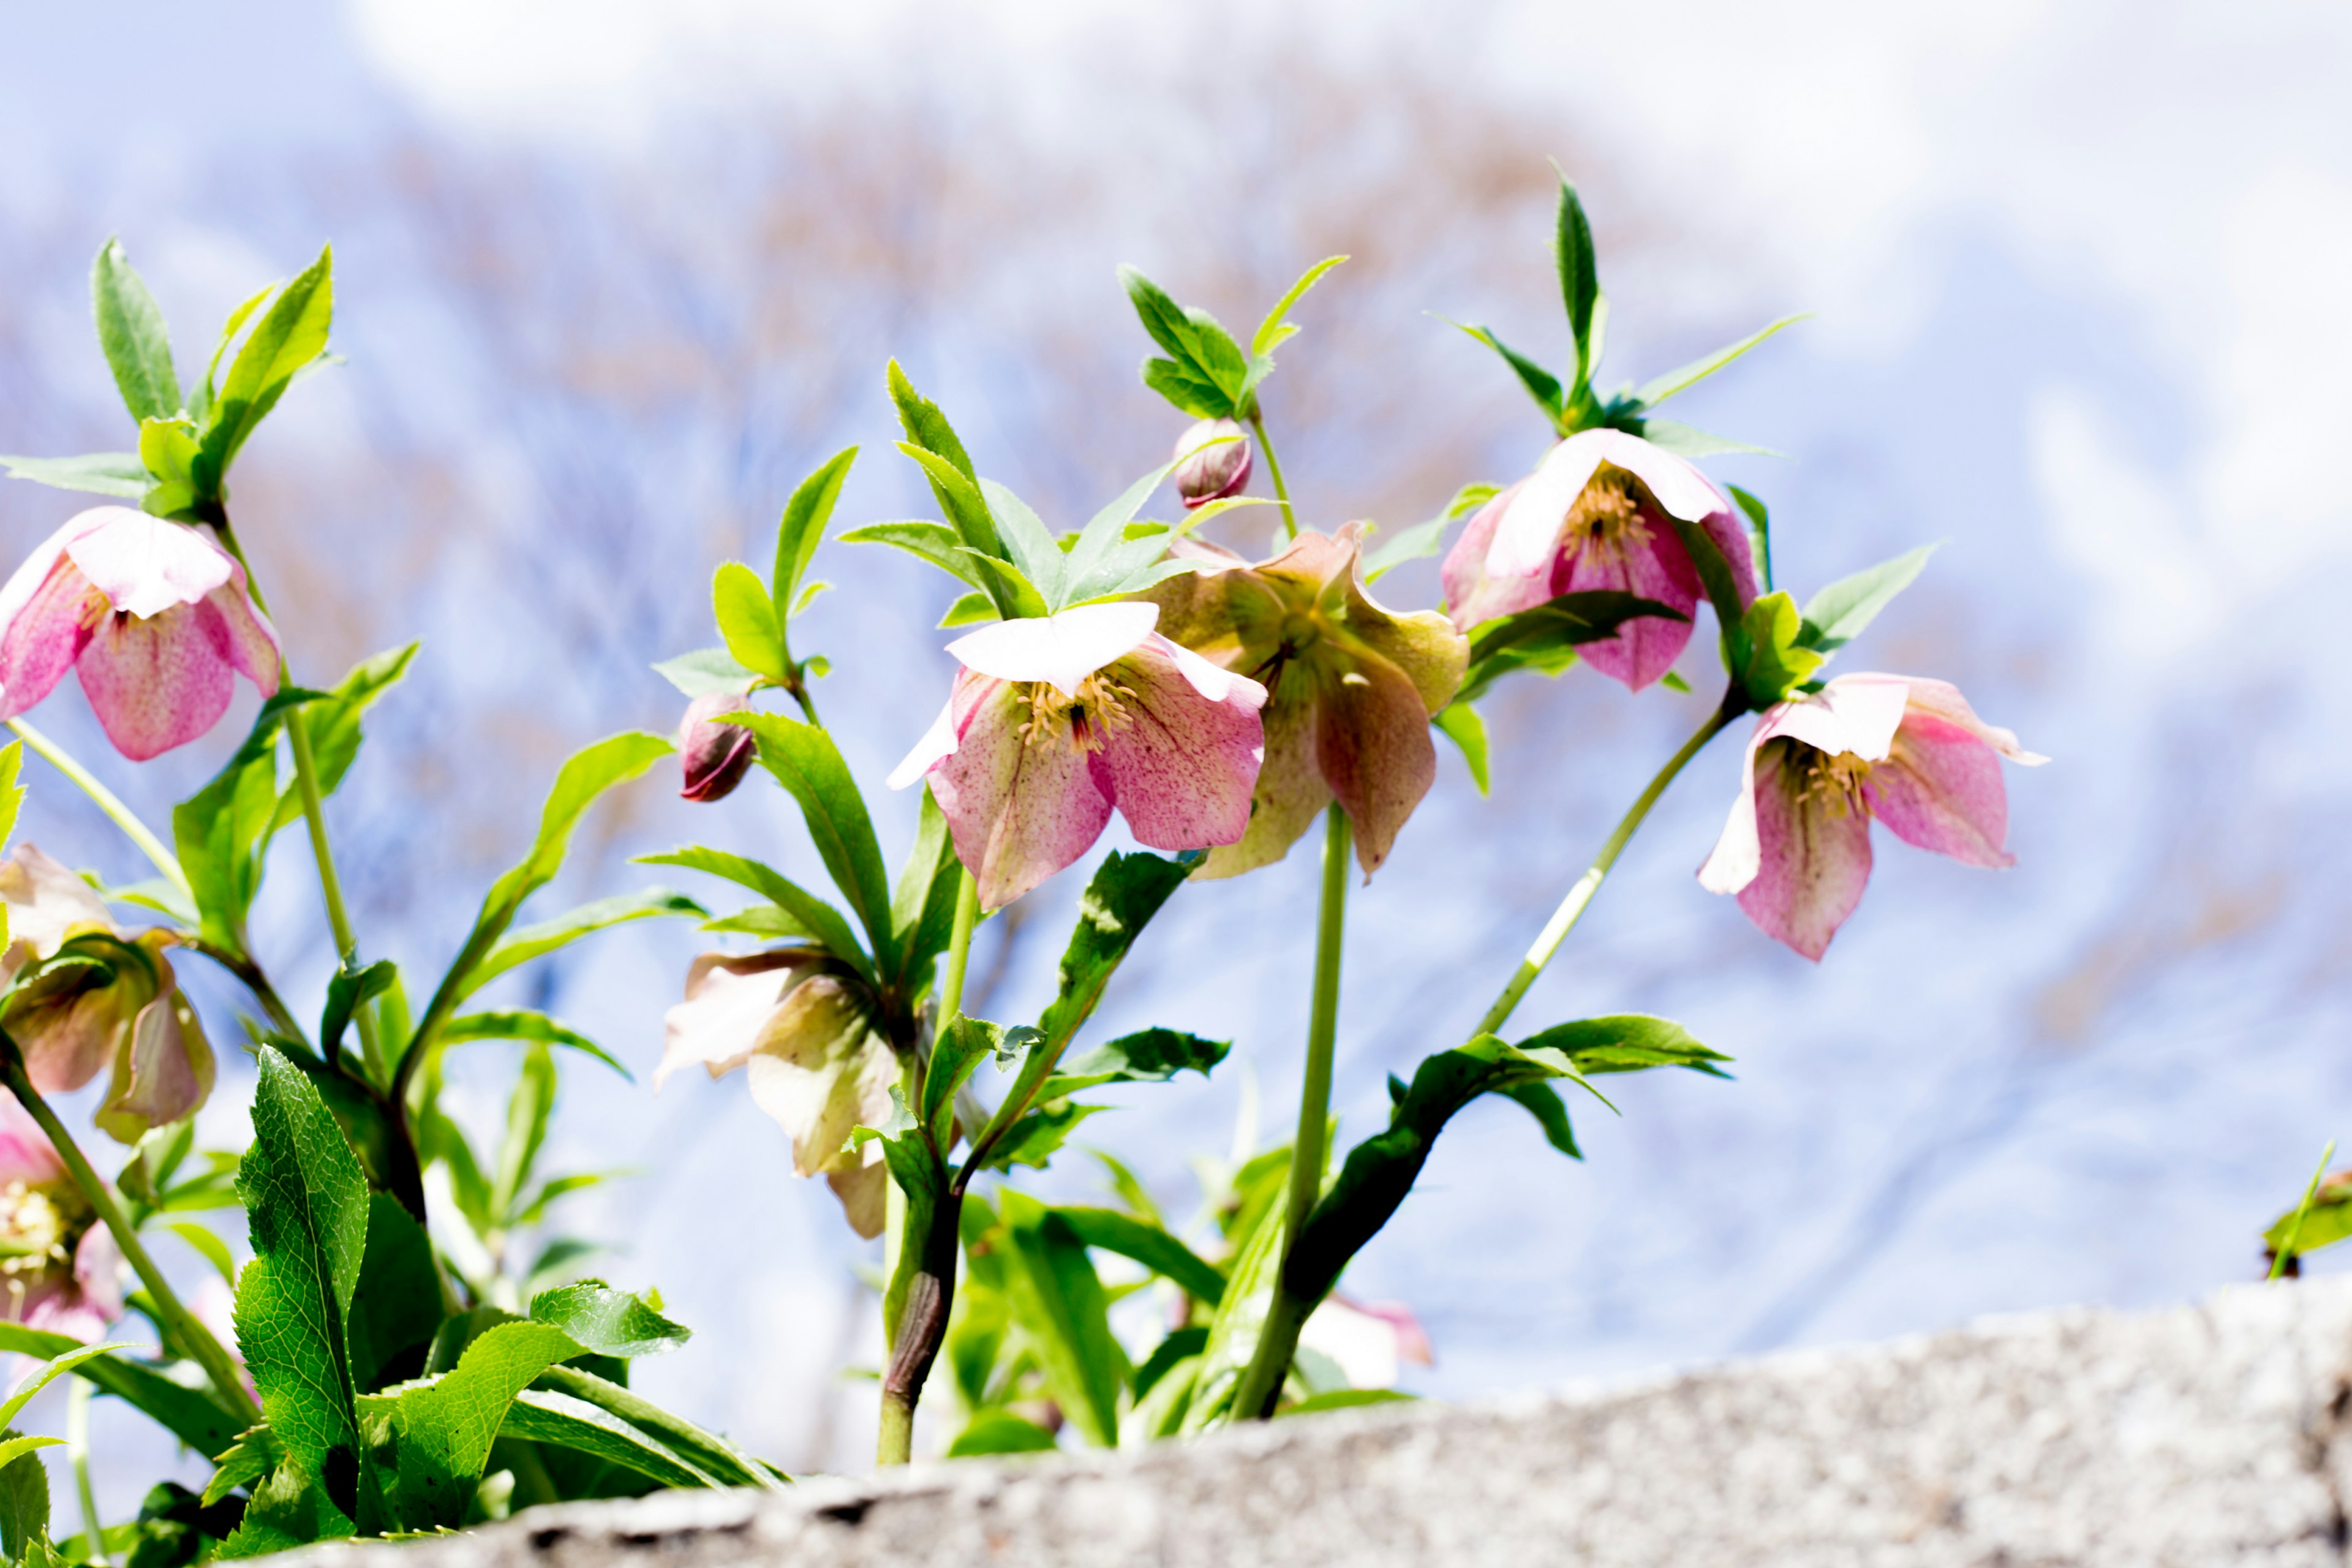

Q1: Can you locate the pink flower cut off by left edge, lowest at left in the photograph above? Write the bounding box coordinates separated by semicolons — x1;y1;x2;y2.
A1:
0;1096;123;1343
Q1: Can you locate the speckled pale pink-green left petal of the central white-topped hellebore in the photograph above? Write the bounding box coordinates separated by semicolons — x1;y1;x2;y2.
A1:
931;670;1110;910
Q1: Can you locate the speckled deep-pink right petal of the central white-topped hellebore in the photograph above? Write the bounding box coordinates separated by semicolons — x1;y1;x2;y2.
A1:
1094;632;1265;849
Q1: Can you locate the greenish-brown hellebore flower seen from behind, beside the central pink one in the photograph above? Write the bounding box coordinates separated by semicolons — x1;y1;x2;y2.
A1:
1143;522;1470;877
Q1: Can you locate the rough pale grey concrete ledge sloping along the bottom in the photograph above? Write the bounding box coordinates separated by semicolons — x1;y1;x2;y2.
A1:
303;1281;2352;1568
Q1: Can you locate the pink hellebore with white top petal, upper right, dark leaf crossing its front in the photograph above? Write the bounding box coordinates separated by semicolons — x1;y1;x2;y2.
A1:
1444;430;1757;691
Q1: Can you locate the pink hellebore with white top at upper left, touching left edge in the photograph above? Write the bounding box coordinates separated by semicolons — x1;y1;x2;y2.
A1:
0;505;277;762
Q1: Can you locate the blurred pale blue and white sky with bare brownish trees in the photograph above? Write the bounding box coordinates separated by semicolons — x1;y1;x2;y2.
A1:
0;0;2352;1514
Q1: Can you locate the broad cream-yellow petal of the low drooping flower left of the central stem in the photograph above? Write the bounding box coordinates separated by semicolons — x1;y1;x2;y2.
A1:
745;976;899;1175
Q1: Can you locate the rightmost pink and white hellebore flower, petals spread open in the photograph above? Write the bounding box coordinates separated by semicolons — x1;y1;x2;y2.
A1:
1698;675;2049;962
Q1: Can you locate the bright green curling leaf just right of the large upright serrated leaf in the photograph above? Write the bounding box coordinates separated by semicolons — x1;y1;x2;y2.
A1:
393;1321;581;1531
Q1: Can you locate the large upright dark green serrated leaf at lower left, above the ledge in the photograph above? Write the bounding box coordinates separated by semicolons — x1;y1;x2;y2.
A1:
235;1046;376;1526
